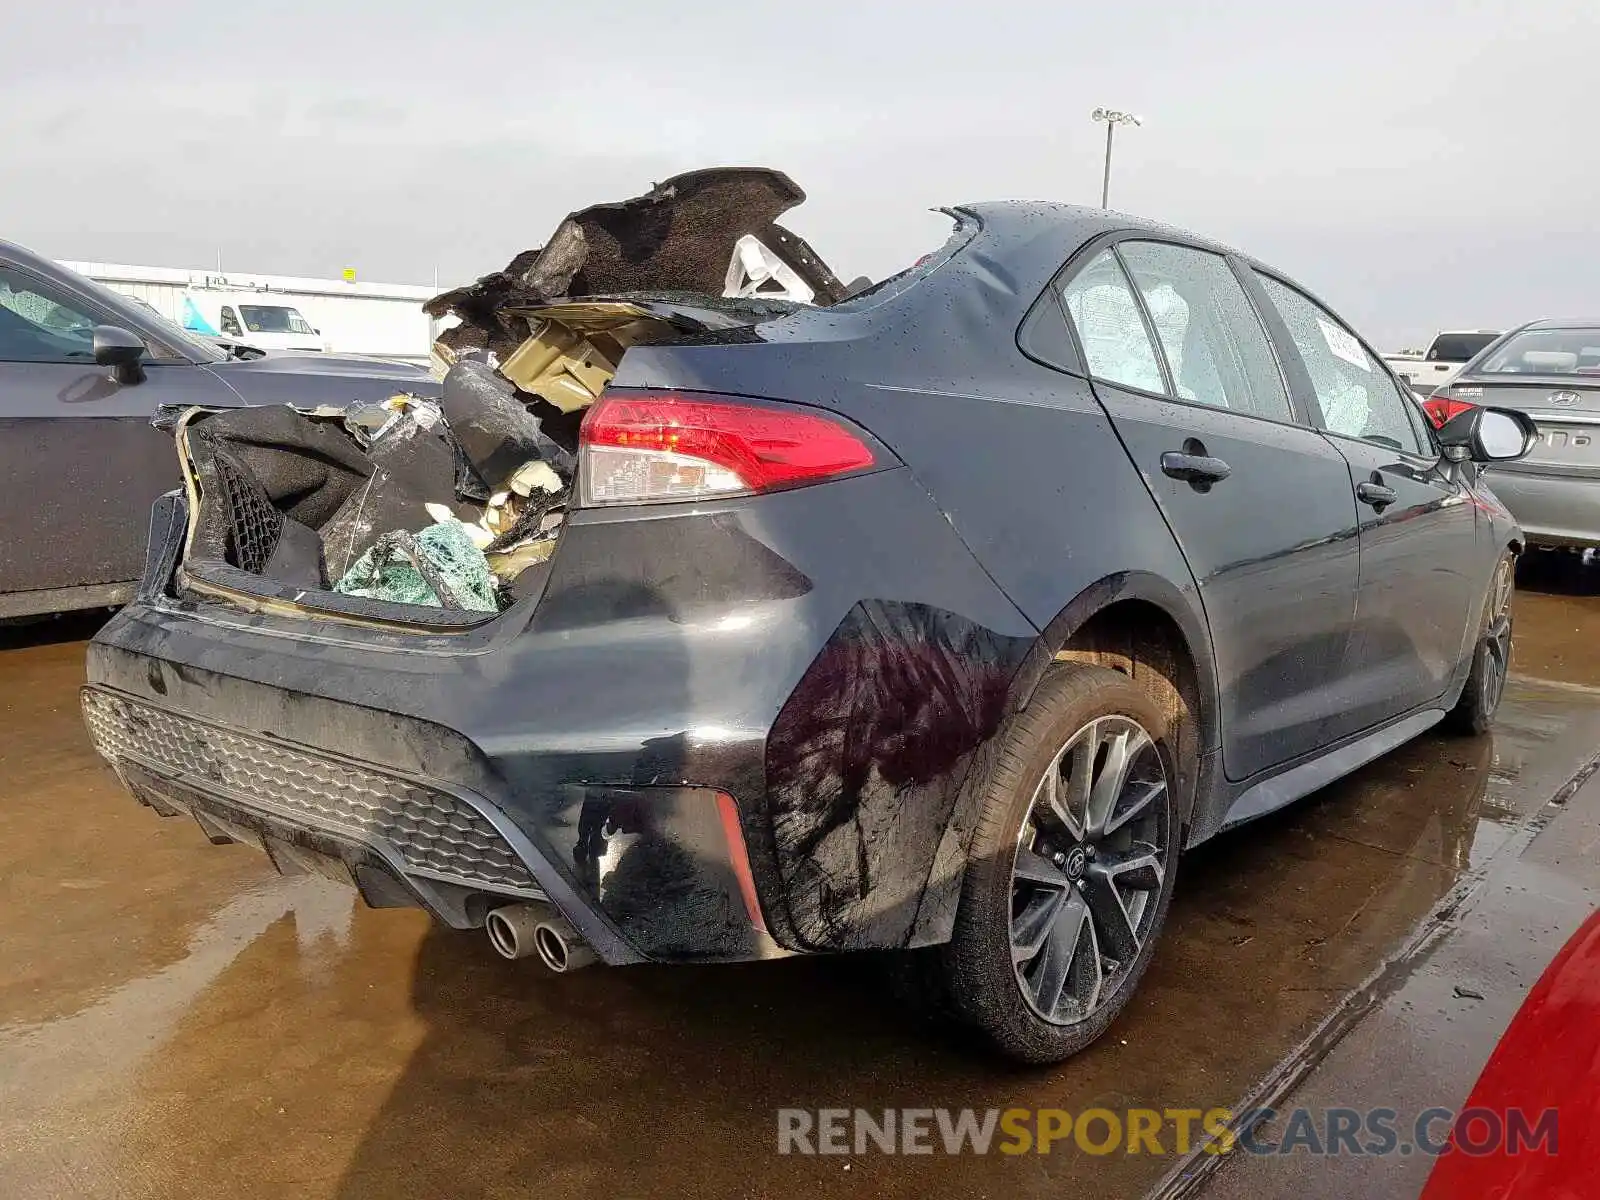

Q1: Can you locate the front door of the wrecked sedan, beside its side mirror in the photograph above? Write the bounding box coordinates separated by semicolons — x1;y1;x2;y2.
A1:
1258;272;1486;733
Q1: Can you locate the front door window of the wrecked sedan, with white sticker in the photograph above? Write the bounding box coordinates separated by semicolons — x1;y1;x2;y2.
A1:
1258;275;1427;454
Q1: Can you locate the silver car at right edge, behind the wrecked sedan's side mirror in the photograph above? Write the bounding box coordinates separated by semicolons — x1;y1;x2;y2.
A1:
1427;318;1600;547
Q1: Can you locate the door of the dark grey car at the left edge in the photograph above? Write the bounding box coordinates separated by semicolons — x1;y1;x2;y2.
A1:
0;258;237;616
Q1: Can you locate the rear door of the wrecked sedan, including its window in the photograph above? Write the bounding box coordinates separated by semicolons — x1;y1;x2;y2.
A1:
1061;238;1357;790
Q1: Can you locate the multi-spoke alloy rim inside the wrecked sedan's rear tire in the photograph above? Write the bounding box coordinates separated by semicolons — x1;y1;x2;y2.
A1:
1011;715;1171;1026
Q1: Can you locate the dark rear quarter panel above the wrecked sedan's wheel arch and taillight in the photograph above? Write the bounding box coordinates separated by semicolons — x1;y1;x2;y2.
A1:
614;227;1200;649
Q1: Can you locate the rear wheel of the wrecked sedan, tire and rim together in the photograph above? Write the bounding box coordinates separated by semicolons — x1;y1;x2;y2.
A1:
939;666;1181;1062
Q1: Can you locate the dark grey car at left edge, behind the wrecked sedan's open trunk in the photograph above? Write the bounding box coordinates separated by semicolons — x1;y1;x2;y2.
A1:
0;242;438;619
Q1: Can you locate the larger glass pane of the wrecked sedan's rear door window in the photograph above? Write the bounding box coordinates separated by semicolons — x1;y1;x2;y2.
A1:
1117;242;1294;421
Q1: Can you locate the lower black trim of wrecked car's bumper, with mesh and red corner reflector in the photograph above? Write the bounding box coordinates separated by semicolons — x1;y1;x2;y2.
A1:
82;681;782;966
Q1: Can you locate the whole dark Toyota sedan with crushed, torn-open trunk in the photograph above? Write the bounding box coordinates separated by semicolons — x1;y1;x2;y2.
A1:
83;168;1533;1062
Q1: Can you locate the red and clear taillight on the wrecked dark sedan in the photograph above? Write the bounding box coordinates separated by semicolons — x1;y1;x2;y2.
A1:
578;392;877;504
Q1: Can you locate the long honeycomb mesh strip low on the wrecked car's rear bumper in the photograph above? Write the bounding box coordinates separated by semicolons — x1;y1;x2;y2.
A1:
83;690;538;890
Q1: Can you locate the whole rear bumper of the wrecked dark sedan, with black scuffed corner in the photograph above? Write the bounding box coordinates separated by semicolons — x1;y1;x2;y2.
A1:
83;470;1035;963
